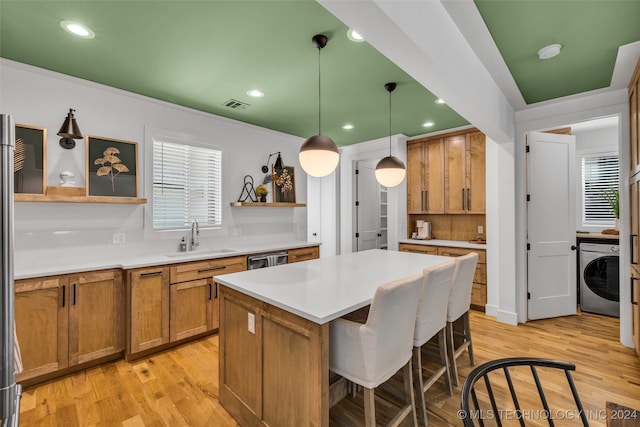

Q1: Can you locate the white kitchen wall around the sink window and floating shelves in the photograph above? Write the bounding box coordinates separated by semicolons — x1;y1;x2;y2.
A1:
0;60;307;269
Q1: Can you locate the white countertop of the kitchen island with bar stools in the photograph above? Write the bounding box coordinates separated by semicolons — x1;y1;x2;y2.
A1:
214;249;451;324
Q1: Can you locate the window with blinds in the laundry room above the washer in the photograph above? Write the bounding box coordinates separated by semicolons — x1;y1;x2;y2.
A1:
582;153;618;226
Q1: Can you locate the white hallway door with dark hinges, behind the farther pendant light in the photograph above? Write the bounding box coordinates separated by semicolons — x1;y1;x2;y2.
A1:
354;160;380;251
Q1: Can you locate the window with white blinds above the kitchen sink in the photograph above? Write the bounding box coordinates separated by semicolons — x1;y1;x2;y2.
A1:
153;138;222;230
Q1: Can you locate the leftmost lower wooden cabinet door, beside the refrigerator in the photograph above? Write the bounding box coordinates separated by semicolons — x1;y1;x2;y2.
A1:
15;277;69;382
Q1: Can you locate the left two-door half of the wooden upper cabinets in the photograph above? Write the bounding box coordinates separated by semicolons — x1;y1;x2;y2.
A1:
407;139;444;214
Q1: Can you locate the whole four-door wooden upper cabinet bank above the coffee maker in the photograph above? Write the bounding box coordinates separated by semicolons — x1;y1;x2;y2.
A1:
407;129;486;215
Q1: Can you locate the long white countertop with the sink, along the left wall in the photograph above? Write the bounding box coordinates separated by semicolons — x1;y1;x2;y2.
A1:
14;240;319;279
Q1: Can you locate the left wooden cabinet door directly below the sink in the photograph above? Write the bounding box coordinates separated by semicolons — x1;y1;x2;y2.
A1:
169;278;217;342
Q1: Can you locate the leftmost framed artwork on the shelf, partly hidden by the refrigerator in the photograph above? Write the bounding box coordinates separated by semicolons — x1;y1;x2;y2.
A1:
13;124;47;194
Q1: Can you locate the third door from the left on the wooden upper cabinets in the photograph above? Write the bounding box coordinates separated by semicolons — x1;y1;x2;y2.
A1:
444;135;467;213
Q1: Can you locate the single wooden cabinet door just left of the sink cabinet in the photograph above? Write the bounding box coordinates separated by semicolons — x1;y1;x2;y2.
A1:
127;267;169;353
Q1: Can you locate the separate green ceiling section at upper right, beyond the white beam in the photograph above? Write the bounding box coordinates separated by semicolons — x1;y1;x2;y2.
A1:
475;0;640;104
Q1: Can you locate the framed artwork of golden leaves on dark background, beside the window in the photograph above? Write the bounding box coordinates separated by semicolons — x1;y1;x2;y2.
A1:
86;135;138;197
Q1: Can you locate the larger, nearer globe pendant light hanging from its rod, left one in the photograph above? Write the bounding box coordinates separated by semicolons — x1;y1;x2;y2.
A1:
298;34;340;178
